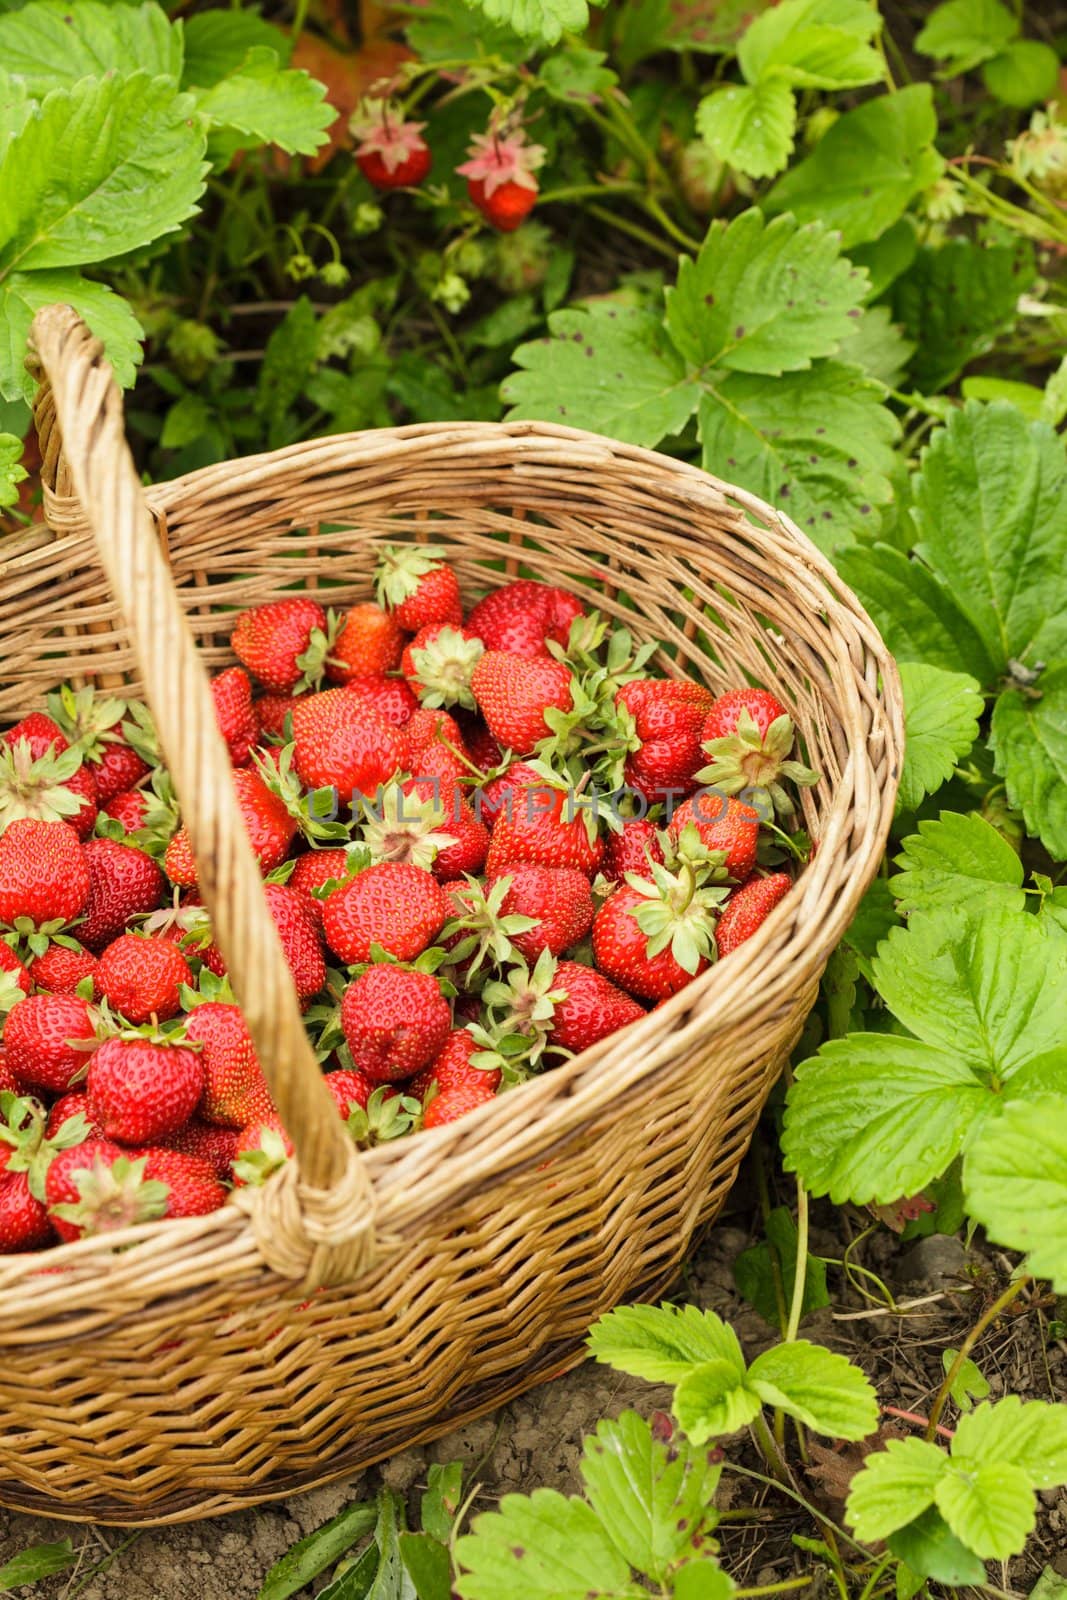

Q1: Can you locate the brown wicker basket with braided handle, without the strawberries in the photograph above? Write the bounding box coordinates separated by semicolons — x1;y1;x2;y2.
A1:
0;307;902;1525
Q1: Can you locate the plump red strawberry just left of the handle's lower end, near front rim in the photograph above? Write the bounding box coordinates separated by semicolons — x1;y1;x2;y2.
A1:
86;1038;203;1144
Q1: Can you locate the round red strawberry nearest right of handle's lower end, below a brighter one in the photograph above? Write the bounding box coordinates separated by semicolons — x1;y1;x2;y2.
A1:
341;965;451;1083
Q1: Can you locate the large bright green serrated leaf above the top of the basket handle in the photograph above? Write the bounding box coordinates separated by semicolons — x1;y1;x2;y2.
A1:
0;72;203;277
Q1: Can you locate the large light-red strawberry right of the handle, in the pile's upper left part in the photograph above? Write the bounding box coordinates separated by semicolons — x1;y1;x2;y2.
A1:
293;690;408;803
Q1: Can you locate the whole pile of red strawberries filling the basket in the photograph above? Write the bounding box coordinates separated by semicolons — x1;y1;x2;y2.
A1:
0;546;814;1251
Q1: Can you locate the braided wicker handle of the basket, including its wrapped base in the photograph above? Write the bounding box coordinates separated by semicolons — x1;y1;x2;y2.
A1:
32;306;374;1286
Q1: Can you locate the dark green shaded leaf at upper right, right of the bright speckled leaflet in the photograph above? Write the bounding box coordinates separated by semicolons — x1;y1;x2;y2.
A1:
891;238;1033;394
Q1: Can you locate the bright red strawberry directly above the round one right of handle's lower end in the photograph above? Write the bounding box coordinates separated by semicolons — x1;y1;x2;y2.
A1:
323;861;448;962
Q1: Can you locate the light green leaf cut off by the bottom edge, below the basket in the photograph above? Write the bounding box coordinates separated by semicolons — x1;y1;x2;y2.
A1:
456;1490;648;1600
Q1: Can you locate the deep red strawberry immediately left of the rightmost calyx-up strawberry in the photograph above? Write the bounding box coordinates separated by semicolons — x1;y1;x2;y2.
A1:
614;678;715;805
